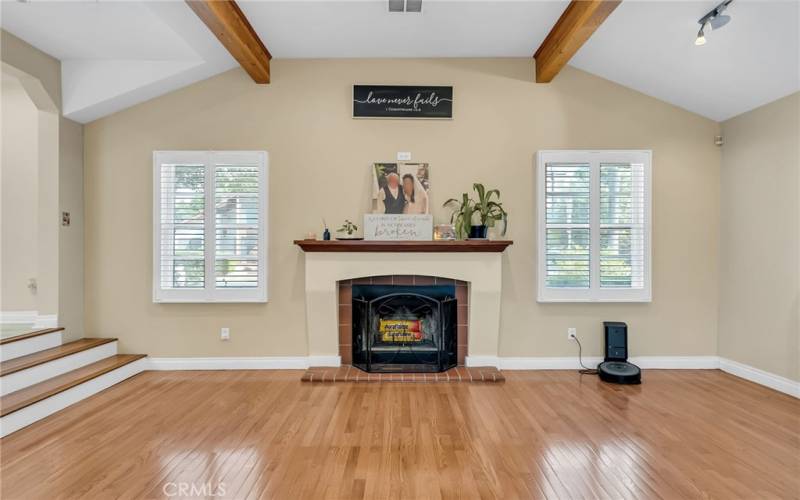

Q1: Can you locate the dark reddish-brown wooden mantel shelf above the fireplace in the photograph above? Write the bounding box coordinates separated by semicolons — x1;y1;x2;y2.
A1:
294;240;514;253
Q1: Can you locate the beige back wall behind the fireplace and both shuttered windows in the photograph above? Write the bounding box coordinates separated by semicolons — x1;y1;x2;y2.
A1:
85;59;720;356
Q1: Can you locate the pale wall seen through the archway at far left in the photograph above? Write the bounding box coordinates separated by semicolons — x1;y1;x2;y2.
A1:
0;75;39;311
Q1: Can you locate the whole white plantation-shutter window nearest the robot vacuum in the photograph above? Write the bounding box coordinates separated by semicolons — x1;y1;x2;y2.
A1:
537;151;651;302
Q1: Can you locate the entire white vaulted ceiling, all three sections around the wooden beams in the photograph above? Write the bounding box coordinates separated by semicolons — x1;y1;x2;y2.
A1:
0;0;800;122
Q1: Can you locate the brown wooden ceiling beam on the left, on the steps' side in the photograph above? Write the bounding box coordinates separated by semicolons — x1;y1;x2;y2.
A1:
186;0;272;83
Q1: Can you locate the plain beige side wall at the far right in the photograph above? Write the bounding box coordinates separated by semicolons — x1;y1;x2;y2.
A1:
719;93;800;380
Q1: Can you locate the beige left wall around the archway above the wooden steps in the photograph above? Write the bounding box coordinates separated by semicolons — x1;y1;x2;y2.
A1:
0;30;83;339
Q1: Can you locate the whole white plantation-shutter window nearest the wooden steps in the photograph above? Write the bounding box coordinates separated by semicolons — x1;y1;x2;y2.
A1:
153;151;268;302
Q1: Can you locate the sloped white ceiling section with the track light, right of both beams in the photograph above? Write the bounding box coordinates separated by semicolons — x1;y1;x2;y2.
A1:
570;0;800;121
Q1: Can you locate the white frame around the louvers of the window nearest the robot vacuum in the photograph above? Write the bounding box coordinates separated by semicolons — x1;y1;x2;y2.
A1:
536;150;653;302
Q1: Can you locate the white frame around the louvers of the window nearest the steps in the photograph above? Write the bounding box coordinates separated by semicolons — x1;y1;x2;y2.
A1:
152;151;269;303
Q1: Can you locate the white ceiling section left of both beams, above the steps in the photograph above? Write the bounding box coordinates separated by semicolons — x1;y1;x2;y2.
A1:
0;0;237;123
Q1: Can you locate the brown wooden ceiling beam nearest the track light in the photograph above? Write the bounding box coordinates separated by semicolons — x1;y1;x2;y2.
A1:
533;0;622;83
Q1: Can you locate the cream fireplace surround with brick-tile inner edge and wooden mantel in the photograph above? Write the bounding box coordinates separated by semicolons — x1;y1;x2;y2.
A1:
295;240;511;366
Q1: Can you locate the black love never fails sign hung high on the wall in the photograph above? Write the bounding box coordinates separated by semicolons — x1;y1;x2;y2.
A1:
353;85;453;120
